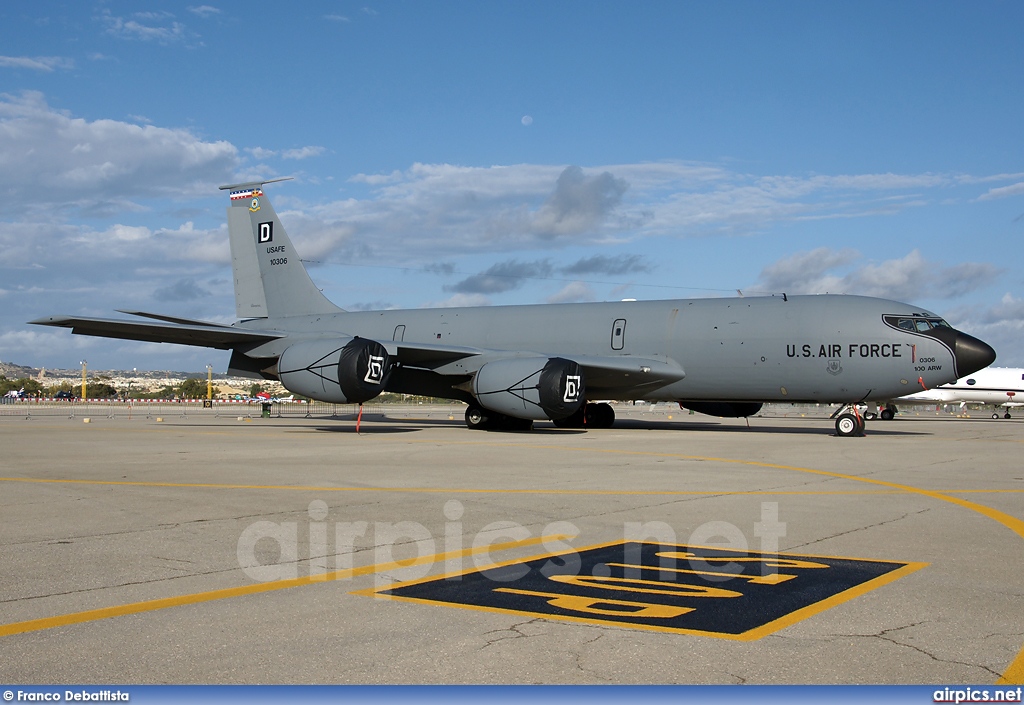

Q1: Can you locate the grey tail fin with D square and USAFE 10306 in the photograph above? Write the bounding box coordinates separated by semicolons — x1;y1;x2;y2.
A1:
221;181;342;319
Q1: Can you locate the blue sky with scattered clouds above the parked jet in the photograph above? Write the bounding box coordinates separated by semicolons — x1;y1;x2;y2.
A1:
0;0;1024;371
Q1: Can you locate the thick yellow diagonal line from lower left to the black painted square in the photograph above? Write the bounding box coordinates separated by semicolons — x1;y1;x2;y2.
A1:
0;536;567;637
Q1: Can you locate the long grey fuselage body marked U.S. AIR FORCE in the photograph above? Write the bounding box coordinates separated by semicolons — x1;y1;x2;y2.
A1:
240;295;963;403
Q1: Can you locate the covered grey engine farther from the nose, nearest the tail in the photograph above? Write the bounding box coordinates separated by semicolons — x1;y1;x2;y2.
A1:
278;338;391;404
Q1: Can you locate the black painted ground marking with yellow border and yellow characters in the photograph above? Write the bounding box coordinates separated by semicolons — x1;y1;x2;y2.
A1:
359;541;927;640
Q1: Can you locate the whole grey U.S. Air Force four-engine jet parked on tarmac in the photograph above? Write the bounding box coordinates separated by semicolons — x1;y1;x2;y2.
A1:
31;179;995;436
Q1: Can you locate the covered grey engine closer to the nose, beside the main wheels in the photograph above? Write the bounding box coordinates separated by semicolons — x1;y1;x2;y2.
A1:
473;358;586;419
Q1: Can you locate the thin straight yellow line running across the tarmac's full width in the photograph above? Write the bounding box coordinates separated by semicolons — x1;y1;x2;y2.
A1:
0;475;1024;497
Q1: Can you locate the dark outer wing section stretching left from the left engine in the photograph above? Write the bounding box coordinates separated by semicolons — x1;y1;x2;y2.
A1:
29;316;285;349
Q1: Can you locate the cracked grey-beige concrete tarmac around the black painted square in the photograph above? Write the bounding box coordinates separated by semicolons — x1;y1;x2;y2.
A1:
0;410;1024;683
